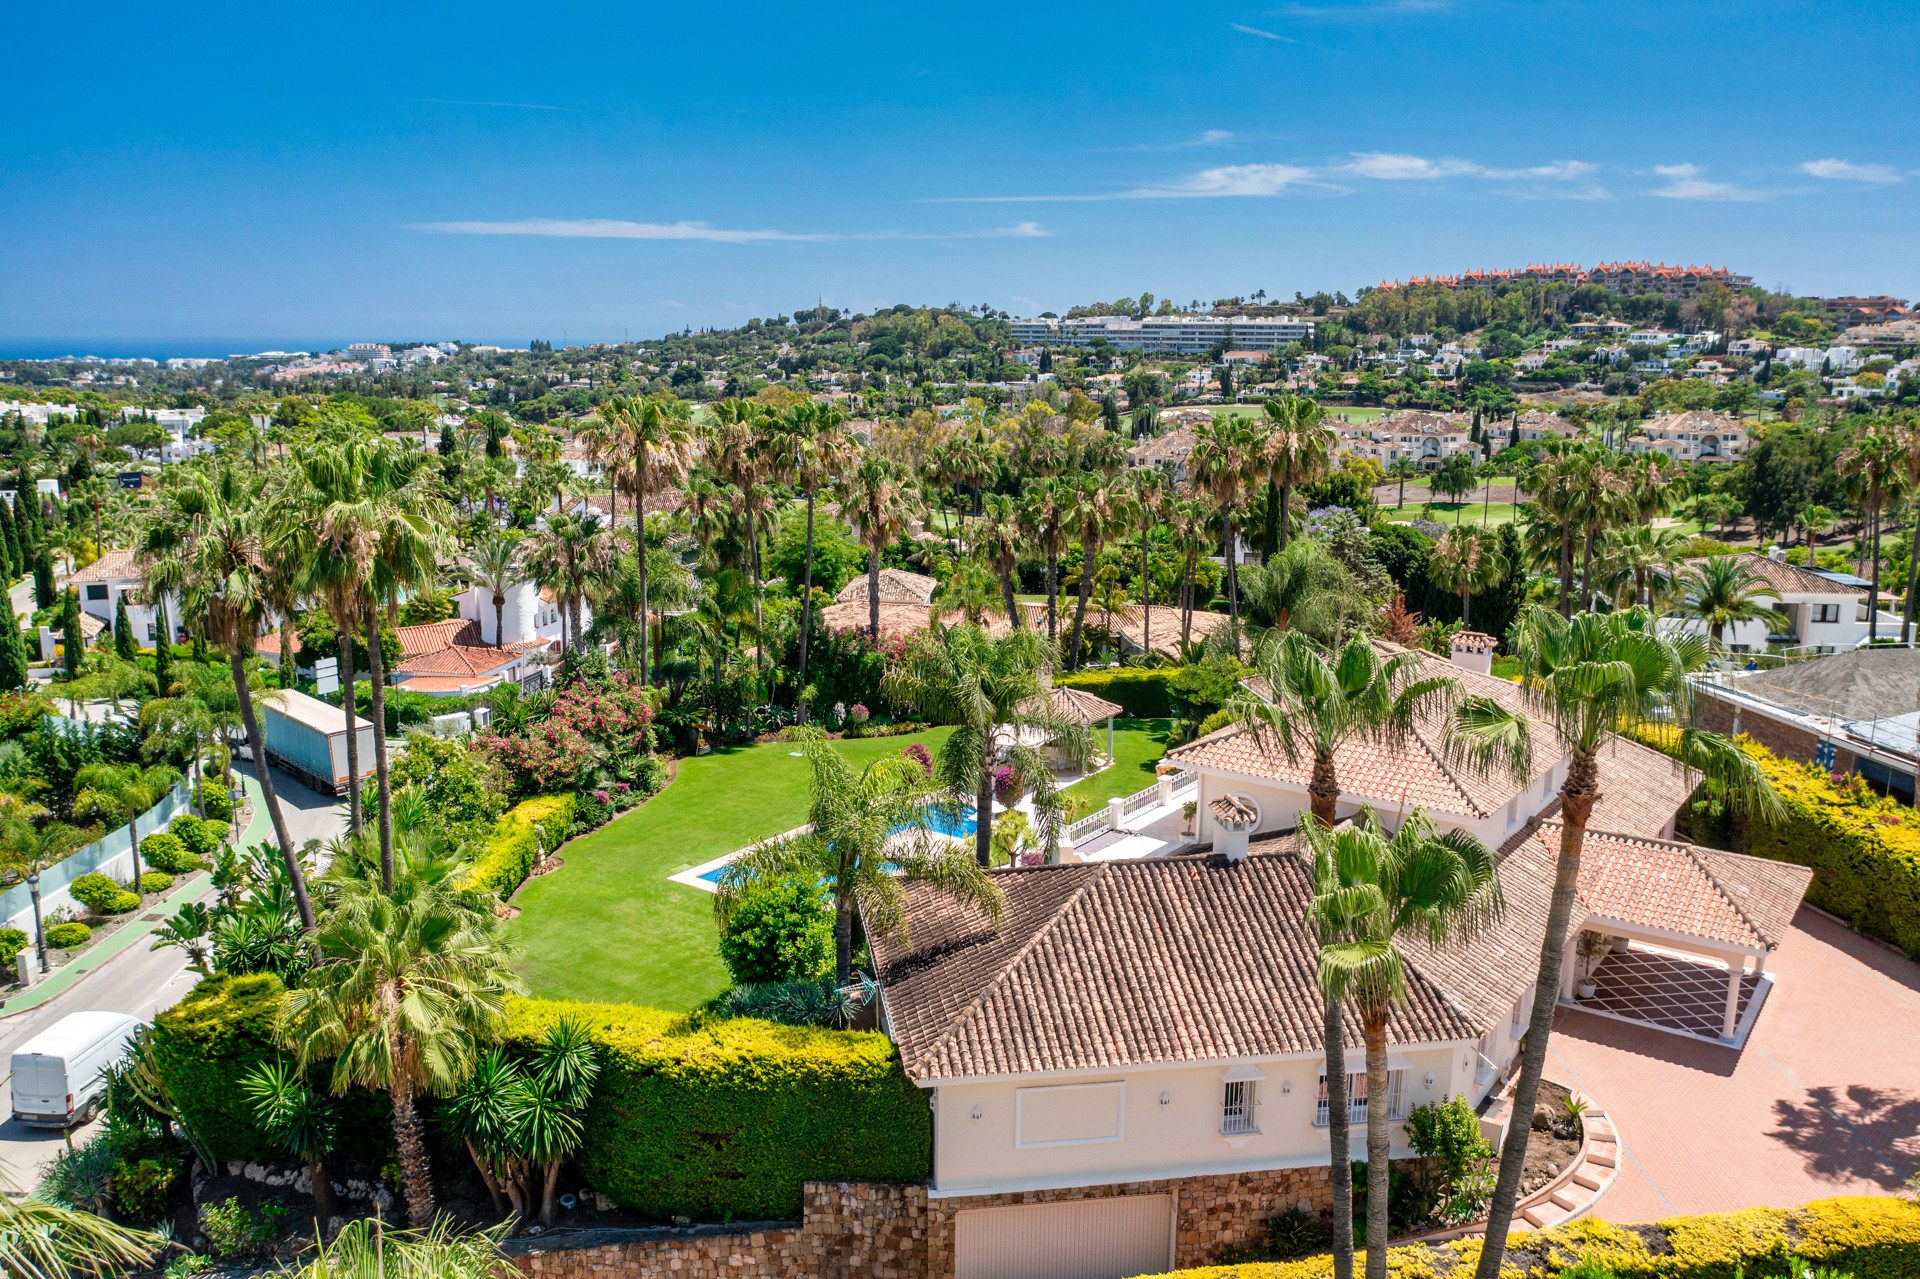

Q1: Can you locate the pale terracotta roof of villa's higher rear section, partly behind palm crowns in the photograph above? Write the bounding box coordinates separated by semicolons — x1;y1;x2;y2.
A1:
1167;653;1567;818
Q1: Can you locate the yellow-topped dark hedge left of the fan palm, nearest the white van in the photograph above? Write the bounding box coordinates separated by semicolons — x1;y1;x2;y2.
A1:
152;972;286;1160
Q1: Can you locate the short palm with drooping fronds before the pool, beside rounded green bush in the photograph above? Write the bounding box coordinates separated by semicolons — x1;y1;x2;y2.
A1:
714;722;1006;985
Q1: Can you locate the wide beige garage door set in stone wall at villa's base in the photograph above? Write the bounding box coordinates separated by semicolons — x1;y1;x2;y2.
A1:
954;1195;1173;1279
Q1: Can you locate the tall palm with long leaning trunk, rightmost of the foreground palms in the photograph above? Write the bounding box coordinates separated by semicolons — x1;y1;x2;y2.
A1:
1455;605;1782;1279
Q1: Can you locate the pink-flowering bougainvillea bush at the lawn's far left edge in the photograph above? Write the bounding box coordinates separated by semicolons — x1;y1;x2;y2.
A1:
474;674;653;793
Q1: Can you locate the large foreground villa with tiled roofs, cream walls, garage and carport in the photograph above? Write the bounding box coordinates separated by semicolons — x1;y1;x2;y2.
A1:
874;655;1811;1273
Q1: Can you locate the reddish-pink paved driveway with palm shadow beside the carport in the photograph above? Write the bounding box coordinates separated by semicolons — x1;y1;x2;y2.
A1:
1548;894;1920;1221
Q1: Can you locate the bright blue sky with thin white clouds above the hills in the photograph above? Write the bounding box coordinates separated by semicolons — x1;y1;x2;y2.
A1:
0;0;1920;353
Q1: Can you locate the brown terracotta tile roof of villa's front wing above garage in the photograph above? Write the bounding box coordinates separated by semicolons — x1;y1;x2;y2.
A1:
874;851;1482;1081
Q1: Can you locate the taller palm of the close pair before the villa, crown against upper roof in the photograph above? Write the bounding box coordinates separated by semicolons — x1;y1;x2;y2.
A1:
1227;630;1459;1273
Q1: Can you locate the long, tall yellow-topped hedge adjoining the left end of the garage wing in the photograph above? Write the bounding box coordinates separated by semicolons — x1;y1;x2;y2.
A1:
507;999;933;1221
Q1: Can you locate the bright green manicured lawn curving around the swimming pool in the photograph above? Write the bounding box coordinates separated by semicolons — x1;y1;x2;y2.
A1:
509;728;952;1010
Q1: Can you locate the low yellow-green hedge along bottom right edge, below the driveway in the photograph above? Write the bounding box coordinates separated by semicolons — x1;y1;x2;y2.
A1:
1142;1198;1920;1279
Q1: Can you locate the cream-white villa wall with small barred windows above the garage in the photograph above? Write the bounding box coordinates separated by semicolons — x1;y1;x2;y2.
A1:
929;1043;1476;1196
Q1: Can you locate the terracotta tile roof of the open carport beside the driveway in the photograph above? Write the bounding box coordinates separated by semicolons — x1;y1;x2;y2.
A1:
1503;822;1812;951
